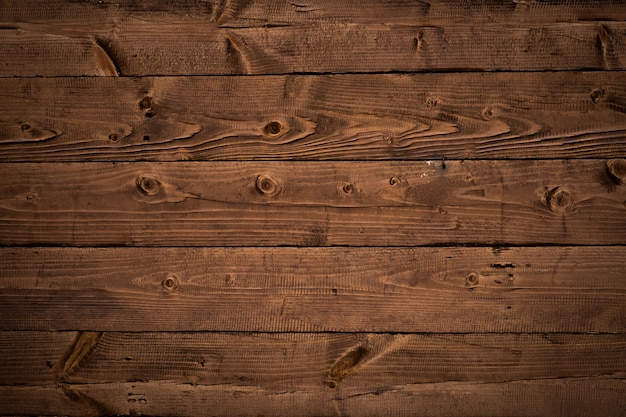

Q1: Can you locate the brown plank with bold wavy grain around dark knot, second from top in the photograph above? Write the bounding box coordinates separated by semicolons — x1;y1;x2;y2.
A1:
0;73;626;162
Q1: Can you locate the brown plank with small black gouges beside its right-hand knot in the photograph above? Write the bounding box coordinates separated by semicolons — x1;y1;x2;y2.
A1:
0;246;626;330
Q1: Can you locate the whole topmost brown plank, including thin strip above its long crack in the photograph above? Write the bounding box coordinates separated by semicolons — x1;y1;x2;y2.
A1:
0;0;626;76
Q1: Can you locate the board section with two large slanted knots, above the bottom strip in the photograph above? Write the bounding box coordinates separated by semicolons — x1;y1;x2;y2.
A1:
0;332;626;390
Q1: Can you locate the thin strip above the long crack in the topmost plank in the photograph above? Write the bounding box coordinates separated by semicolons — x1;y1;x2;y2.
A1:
0;0;626;27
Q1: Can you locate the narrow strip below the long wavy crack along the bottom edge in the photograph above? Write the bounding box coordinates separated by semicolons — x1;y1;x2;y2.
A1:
0;378;626;417
